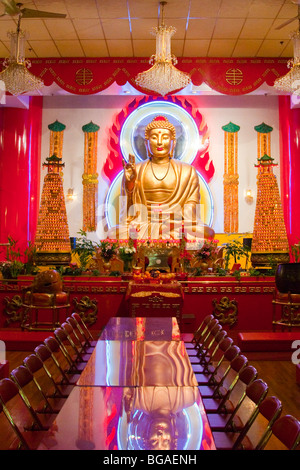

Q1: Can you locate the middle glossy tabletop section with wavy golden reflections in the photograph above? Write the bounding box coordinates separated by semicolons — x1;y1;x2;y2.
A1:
77;340;197;387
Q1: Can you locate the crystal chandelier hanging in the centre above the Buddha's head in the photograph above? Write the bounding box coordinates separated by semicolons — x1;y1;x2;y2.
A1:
135;2;191;96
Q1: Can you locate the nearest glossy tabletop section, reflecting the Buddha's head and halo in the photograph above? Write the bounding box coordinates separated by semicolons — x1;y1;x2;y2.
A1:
39;387;215;450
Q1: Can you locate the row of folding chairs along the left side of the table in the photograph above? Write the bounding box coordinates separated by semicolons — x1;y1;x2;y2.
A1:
0;313;96;450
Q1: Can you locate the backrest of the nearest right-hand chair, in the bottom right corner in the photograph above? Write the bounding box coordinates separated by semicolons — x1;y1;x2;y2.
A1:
272;415;300;450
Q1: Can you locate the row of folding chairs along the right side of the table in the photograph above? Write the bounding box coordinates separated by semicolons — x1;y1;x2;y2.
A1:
186;315;300;450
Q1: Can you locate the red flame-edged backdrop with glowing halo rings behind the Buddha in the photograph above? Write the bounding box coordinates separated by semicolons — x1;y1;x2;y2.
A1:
102;96;215;228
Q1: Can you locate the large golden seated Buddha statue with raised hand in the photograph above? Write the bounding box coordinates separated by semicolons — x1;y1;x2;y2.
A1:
109;116;214;240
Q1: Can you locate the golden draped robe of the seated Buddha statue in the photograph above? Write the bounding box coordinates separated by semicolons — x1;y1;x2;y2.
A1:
109;159;213;239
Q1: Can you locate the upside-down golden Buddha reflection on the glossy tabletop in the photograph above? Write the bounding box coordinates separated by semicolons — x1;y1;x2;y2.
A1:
124;341;199;450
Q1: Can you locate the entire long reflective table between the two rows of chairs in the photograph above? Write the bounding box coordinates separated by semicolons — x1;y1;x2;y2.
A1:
39;317;215;450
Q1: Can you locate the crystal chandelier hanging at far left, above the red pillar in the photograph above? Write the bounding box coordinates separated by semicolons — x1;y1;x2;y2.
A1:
0;23;44;95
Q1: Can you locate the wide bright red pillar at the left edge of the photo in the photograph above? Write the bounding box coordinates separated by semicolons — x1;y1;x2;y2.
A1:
0;97;43;258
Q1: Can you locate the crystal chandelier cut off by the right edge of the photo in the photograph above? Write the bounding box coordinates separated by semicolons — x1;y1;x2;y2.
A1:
274;31;300;96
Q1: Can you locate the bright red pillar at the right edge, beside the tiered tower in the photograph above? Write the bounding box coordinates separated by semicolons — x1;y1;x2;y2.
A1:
278;96;300;244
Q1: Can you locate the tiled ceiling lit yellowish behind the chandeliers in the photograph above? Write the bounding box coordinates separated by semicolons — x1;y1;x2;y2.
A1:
0;0;299;58
